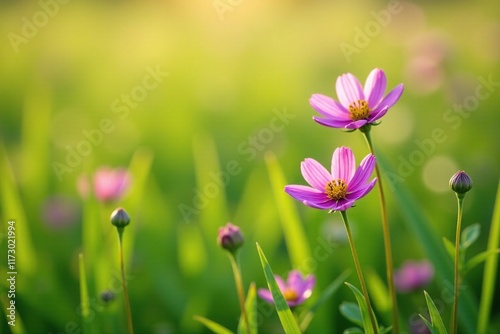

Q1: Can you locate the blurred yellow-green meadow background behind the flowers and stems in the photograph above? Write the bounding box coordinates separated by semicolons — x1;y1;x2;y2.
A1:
0;0;500;333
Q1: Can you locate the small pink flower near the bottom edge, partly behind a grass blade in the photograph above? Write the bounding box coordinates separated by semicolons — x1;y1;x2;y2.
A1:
257;270;316;307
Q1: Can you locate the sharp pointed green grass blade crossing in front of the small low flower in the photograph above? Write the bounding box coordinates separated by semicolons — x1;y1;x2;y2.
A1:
257;243;300;334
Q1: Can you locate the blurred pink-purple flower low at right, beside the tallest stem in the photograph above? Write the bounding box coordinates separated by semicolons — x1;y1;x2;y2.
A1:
394;260;434;292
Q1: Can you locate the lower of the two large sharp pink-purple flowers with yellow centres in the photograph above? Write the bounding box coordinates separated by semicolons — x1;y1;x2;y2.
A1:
285;147;377;211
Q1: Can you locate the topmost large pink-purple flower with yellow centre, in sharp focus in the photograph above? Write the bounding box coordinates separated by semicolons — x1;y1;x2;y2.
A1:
309;68;404;130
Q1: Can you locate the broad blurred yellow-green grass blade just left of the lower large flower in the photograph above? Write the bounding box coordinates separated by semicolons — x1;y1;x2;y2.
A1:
265;153;312;274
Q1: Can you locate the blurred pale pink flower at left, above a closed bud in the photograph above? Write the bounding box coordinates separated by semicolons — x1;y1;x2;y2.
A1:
94;167;130;202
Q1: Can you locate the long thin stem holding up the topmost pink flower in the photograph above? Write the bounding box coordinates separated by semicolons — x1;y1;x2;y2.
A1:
362;128;399;333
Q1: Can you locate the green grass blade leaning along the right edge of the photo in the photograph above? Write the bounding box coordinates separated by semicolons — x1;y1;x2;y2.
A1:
477;182;500;334
